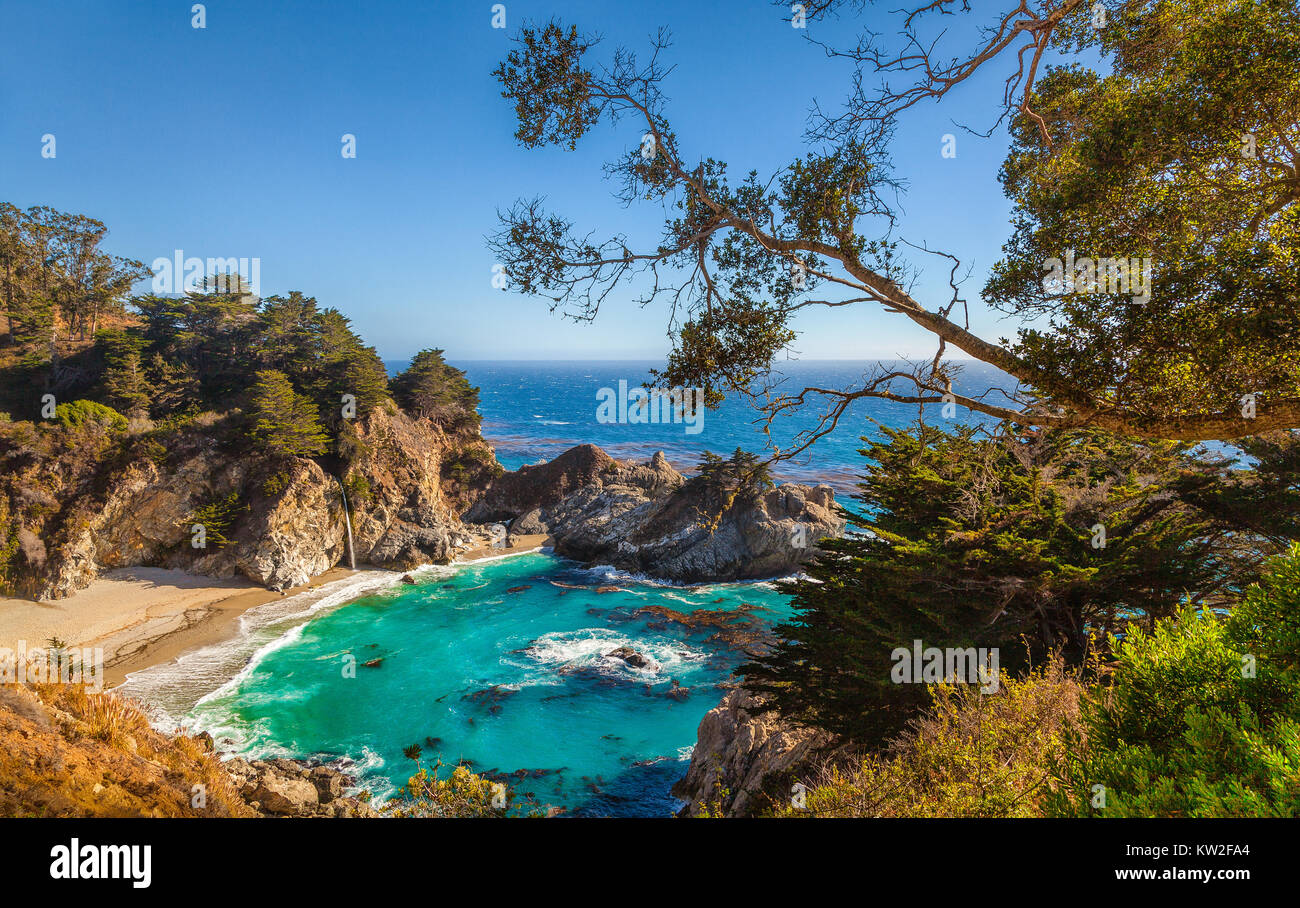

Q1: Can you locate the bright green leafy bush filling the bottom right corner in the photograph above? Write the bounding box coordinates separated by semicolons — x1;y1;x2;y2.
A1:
1050;545;1300;817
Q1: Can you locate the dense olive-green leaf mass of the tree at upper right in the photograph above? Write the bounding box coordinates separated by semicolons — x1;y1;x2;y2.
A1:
984;0;1300;425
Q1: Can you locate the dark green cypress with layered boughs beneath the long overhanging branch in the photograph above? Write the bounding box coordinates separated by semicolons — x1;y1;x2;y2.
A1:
741;424;1253;744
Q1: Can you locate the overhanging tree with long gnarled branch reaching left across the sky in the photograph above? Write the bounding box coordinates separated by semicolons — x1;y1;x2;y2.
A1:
491;0;1300;457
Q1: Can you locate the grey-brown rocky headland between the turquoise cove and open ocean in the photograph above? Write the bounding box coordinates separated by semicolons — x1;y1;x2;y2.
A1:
467;445;844;583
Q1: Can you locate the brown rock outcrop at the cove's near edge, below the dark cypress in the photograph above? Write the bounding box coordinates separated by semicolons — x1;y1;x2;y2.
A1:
672;689;835;817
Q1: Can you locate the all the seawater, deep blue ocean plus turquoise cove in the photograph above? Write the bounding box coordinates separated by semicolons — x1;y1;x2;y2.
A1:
124;362;1013;816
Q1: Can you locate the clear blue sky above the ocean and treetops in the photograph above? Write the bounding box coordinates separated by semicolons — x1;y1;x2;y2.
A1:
0;0;1034;359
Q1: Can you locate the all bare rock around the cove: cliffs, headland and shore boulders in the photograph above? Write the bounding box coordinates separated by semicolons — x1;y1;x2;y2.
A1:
0;426;845;817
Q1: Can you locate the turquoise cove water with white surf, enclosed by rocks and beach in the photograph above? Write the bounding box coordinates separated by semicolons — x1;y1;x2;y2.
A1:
131;553;788;816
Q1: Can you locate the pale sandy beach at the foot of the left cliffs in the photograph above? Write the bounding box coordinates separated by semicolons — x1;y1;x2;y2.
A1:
0;536;547;687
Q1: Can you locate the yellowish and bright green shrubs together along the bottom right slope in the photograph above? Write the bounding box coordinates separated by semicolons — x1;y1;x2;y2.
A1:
775;544;1300;817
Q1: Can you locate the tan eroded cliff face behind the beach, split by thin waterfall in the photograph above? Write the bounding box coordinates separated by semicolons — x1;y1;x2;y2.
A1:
7;400;495;598
